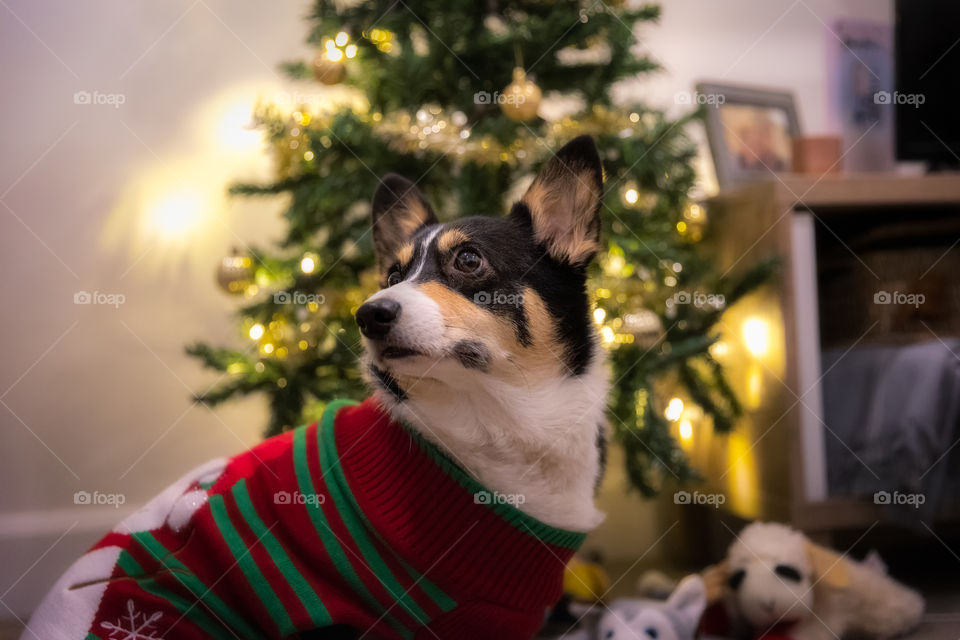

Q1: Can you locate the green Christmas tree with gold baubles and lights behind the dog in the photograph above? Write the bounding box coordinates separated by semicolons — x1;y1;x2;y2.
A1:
188;0;771;495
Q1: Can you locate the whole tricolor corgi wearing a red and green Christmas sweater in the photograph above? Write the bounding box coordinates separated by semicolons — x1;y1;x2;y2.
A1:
23;137;608;640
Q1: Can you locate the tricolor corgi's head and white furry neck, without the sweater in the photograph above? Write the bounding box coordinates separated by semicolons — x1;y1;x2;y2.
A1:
356;136;608;531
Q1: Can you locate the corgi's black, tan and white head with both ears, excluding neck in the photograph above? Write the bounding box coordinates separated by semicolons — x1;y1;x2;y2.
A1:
357;136;603;401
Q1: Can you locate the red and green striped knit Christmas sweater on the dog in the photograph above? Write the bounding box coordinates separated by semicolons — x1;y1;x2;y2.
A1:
24;399;583;640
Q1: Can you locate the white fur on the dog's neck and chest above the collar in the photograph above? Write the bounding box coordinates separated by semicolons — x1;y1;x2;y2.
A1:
380;350;607;532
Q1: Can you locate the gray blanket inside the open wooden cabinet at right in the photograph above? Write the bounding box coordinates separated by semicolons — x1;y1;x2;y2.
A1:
822;339;960;523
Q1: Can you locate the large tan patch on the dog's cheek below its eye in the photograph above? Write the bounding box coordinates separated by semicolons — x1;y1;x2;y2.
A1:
417;282;567;384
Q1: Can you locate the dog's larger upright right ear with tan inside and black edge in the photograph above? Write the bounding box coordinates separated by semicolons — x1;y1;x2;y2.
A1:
510;136;603;267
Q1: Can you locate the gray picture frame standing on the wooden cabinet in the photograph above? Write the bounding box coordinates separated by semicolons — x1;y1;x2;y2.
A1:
696;82;801;189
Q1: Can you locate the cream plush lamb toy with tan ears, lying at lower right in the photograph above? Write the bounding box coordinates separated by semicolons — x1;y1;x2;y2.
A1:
704;522;924;640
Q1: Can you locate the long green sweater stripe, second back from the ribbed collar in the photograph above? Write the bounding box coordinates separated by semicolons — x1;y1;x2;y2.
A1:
293;427;413;639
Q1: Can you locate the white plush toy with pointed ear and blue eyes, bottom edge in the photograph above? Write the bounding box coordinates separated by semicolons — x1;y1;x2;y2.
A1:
563;575;707;640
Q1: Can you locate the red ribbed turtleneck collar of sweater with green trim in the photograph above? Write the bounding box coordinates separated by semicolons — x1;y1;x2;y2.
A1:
322;398;586;608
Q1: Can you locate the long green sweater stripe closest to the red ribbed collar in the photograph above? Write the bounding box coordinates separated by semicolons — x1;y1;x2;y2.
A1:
317;400;429;624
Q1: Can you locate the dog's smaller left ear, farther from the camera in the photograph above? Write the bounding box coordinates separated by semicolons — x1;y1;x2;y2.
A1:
372;173;437;271
